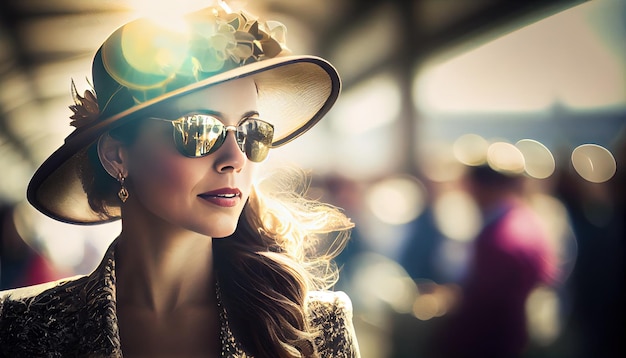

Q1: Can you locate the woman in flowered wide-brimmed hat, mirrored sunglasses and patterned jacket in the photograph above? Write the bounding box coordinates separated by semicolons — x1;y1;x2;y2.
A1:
0;3;359;357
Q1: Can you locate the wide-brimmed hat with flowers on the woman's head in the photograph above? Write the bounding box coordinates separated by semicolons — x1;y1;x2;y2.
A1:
27;6;341;224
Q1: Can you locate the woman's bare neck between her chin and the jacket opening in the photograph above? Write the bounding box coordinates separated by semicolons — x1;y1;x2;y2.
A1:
115;218;215;314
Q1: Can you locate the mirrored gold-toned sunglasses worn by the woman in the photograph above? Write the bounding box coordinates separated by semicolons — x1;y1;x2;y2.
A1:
152;113;274;163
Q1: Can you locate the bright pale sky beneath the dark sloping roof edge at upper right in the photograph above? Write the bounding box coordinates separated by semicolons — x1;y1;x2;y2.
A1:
415;0;626;112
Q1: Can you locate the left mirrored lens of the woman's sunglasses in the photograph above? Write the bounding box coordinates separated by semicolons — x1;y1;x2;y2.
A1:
173;115;224;157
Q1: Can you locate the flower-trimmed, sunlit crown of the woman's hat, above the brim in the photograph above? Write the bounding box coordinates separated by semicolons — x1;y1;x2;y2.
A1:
102;7;289;103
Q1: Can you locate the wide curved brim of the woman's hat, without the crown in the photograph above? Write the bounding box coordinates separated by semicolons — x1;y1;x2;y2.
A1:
27;56;341;225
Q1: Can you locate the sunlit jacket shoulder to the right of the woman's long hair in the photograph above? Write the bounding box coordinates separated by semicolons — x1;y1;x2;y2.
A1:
307;291;359;357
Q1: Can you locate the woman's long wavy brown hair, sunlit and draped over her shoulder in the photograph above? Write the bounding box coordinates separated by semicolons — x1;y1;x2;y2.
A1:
80;121;353;358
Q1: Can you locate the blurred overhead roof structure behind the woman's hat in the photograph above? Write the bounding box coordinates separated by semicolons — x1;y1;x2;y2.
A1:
0;0;583;202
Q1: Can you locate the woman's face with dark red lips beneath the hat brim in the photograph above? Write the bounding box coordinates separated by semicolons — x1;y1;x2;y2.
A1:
126;78;258;237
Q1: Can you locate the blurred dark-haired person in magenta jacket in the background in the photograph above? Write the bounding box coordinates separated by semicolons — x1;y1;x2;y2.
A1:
435;165;558;358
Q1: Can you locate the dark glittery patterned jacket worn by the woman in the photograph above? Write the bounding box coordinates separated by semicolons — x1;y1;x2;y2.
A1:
0;246;359;358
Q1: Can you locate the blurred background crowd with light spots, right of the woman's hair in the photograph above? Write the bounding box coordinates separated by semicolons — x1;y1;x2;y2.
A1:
325;136;626;358
